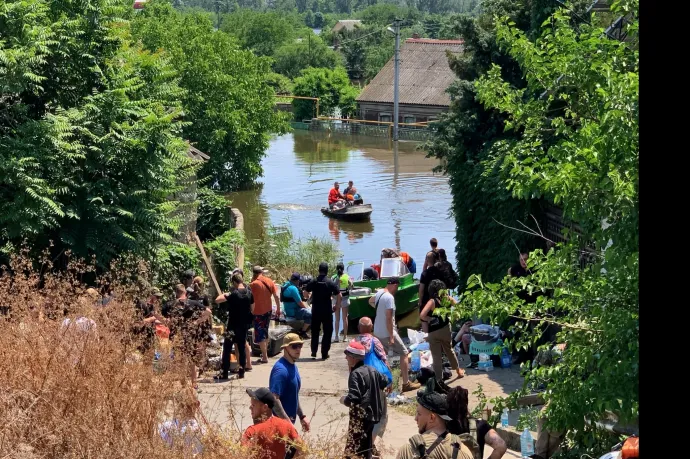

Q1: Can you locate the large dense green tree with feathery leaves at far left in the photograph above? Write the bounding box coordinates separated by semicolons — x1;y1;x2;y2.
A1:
0;0;194;266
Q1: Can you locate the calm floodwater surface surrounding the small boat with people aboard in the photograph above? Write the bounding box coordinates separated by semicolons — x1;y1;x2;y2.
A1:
230;131;455;272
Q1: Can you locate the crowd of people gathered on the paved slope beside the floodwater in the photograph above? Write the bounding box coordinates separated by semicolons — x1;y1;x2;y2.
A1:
123;237;548;459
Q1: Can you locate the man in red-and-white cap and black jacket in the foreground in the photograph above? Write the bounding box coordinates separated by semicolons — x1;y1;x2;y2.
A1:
340;340;388;459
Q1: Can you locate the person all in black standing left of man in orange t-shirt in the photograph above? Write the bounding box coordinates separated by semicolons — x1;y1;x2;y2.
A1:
214;272;254;380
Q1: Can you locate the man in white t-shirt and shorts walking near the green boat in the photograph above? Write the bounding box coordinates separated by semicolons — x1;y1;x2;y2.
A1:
369;277;421;392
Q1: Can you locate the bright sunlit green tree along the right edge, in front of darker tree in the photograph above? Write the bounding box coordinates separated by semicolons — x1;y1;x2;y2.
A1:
438;0;639;457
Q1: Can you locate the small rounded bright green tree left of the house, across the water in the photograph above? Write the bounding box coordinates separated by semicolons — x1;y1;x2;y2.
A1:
292;67;359;120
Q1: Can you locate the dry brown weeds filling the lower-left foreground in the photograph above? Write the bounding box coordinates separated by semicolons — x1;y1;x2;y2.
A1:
0;252;366;459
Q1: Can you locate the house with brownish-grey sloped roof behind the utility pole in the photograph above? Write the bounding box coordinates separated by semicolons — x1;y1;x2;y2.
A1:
357;38;463;123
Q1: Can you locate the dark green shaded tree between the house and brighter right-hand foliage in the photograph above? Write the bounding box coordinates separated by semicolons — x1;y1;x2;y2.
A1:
426;0;582;283
